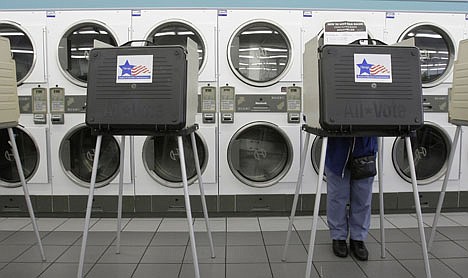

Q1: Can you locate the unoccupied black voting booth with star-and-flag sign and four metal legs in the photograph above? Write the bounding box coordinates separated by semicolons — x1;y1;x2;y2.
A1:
78;39;215;278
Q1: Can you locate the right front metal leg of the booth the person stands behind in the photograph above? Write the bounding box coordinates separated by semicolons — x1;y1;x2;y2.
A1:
405;137;431;278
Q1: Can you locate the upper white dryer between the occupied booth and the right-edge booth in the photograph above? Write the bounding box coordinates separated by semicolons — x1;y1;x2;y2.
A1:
384;12;465;95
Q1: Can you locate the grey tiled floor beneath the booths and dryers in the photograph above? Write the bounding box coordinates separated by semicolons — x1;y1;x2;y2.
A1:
0;213;468;278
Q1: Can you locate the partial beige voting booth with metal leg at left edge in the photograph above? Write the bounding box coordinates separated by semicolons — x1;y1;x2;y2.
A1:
0;37;46;261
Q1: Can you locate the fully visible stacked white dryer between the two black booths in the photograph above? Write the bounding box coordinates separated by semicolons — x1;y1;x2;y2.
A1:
218;10;302;211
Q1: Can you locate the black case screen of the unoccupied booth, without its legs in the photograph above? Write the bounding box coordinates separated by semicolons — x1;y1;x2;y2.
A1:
86;40;198;135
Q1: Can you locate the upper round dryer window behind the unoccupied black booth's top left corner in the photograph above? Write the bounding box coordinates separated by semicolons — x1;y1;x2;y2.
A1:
57;22;117;87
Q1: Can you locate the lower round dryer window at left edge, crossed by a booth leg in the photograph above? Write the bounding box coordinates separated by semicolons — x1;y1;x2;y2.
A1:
0;127;40;187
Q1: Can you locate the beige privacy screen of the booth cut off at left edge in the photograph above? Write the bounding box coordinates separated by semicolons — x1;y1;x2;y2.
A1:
0;37;19;128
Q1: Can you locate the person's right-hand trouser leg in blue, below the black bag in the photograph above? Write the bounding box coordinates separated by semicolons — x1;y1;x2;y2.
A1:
349;177;374;241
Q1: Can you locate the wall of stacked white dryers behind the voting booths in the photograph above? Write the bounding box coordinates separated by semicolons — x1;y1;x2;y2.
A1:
0;0;468;216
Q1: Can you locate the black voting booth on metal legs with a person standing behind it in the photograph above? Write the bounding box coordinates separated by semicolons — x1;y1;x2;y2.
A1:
283;37;431;278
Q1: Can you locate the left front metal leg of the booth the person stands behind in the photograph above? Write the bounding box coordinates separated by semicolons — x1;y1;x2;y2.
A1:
305;137;328;278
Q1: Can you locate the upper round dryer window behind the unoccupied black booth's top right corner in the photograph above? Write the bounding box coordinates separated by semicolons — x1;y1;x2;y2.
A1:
147;22;205;70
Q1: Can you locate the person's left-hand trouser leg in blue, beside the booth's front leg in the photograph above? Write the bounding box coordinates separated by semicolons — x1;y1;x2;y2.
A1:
325;167;350;240
